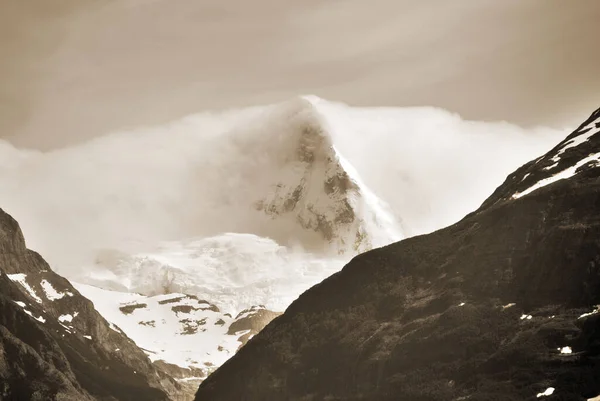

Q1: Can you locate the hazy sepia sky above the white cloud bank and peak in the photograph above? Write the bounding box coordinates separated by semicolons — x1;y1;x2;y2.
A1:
0;0;600;149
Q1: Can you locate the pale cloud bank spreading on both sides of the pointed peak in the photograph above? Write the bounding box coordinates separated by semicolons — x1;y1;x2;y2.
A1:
0;98;566;276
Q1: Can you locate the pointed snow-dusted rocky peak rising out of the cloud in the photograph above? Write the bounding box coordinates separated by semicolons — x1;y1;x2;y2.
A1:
255;96;402;254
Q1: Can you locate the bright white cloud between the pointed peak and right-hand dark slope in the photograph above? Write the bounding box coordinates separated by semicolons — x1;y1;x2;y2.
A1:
319;102;568;235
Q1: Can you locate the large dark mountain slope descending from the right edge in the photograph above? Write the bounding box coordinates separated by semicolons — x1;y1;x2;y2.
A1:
196;111;600;401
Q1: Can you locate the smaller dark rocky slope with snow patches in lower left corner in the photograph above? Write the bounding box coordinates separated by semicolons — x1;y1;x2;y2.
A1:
0;210;179;401
